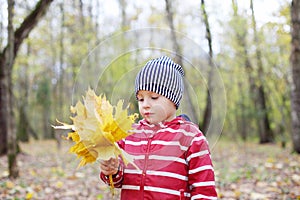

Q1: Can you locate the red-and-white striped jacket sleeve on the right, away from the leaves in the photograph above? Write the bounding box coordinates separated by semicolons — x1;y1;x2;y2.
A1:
186;132;217;199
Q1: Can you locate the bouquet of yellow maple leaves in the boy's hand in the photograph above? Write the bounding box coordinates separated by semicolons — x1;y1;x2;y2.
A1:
53;89;138;192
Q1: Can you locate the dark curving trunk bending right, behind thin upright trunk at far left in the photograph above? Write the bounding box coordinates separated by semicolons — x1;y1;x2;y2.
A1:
0;0;53;155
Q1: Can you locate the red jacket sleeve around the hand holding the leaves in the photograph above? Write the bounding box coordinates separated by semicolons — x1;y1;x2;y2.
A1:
100;140;124;188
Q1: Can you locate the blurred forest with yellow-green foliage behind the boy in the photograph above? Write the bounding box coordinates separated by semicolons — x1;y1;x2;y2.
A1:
0;0;300;177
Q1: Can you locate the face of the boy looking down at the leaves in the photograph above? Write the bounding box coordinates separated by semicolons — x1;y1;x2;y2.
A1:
137;90;176;124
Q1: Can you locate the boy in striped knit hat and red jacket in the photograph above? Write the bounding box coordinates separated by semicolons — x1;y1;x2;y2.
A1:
100;56;217;200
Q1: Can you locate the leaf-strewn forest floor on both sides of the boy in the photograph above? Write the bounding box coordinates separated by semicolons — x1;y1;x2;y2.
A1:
0;140;300;200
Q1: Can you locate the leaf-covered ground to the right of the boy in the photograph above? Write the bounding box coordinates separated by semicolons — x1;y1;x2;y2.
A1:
212;141;300;200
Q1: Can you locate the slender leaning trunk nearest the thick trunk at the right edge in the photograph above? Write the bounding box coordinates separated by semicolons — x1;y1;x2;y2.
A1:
250;0;274;143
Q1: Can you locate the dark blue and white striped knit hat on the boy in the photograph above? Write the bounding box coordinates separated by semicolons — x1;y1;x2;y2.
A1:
135;56;184;109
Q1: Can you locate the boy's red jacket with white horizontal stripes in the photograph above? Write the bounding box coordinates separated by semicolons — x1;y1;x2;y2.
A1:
100;117;217;200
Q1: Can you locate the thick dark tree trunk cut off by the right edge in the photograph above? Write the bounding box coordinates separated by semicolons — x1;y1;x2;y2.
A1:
291;0;300;154
